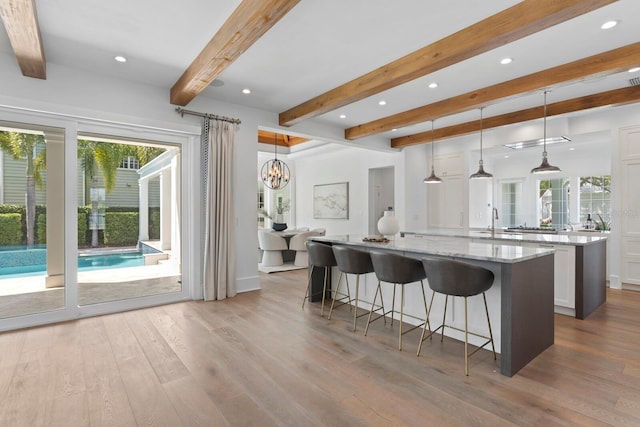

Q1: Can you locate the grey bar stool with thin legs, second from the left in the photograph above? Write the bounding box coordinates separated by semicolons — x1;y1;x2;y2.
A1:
329;245;384;332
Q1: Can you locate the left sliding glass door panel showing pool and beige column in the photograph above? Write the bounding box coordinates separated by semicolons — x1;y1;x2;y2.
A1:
0;122;65;318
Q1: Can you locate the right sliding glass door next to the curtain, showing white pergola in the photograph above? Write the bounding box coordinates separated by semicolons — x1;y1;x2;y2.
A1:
77;134;182;306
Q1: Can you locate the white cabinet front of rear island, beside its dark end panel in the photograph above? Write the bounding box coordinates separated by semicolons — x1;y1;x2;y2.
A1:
522;242;576;315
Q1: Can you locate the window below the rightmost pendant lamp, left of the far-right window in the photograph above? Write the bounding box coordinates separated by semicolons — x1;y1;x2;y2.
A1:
538;178;570;230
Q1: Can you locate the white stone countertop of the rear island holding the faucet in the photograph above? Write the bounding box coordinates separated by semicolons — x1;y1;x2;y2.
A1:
400;228;607;246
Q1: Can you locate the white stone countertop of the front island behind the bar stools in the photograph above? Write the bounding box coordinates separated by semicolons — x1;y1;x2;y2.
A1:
310;234;553;263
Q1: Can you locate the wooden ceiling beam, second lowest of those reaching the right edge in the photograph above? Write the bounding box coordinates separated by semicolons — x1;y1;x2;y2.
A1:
345;42;640;140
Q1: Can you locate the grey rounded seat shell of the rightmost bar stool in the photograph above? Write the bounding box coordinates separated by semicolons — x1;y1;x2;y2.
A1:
422;258;494;297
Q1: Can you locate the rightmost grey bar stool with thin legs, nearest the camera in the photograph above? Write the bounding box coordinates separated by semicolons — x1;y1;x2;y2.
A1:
418;258;497;375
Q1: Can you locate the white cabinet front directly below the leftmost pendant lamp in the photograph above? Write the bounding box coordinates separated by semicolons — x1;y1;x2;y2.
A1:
427;175;464;228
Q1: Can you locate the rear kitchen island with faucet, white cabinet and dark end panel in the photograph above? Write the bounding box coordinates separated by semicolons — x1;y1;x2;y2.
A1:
400;229;607;319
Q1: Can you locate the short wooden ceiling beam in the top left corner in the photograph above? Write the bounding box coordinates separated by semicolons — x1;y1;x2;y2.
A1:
0;0;47;80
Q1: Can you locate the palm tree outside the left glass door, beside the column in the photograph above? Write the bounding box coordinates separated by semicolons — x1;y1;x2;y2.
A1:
0;131;47;247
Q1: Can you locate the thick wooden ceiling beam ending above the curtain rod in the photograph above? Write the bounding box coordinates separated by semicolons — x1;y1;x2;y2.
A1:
170;0;300;106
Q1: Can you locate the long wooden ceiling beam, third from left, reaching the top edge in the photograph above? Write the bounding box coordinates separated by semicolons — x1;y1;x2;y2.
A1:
279;0;618;126
